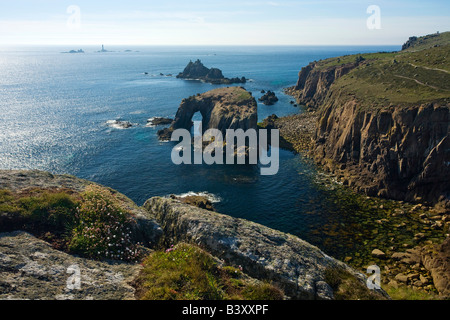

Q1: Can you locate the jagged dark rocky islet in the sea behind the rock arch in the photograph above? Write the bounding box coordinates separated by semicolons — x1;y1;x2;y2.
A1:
177;59;247;84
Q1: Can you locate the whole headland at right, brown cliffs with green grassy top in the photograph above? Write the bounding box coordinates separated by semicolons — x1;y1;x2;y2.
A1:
288;33;450;206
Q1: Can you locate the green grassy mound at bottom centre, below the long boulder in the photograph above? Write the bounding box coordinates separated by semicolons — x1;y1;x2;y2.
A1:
136;243;283;300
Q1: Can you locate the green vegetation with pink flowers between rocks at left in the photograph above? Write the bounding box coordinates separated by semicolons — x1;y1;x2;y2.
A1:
0;185;139;261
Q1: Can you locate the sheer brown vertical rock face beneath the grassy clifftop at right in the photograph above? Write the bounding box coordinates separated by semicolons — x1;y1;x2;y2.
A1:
314;99;450;203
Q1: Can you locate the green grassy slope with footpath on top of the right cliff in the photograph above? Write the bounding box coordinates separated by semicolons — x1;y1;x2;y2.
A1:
318;32;450;107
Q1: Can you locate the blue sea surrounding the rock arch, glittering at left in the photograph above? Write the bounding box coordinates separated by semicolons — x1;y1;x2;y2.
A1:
0;45;400;254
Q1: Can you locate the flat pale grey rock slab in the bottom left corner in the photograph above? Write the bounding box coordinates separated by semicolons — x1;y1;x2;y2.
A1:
0;231;141;300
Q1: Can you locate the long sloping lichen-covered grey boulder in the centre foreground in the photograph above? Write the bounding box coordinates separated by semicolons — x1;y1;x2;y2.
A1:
144;197;386;299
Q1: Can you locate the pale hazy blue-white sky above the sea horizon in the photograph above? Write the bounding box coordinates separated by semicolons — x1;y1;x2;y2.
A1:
0;0;450;45
